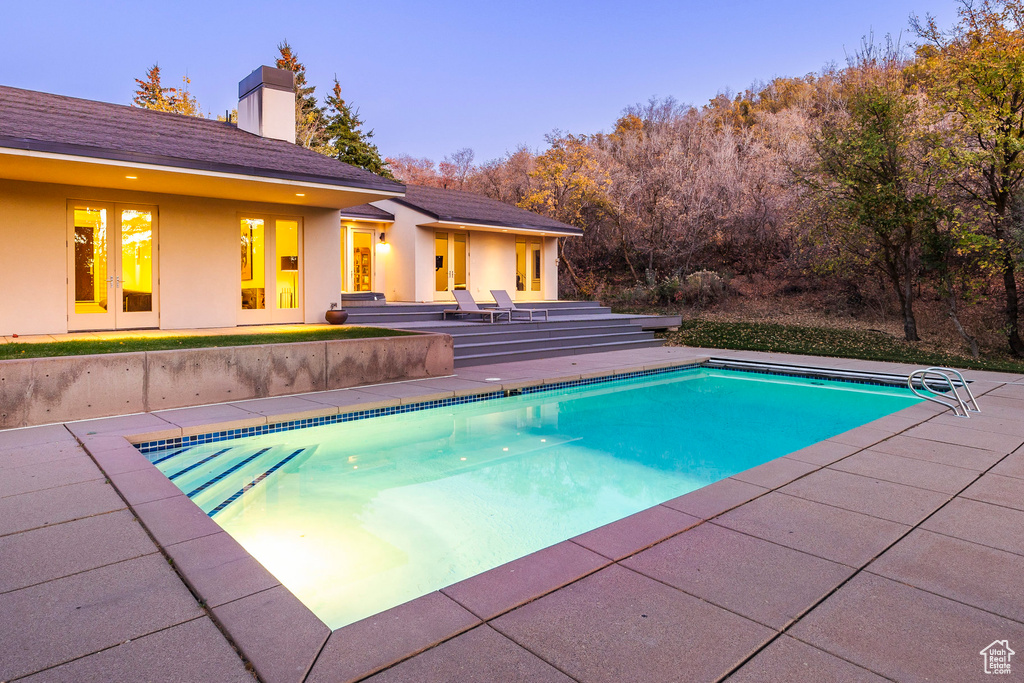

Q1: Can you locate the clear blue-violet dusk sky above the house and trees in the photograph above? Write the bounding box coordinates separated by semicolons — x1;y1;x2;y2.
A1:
0;0;957;163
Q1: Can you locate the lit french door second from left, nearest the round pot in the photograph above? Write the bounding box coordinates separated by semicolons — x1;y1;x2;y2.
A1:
239;215;303;325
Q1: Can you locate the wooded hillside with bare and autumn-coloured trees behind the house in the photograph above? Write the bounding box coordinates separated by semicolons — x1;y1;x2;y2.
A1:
388;0;1024;366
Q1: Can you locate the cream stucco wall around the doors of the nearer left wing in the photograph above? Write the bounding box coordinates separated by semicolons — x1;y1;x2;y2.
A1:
0;180;341;335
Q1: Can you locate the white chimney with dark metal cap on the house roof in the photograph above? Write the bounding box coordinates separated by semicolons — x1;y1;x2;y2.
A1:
239;67;295;144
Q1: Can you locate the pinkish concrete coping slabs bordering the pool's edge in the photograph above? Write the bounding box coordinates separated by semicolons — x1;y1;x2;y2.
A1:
67;354;1013;681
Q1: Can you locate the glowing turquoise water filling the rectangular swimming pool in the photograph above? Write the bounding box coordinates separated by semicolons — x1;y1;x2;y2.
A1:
147;369;919;629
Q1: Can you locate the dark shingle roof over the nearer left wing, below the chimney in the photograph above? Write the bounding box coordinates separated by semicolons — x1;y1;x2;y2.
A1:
0;86;402;191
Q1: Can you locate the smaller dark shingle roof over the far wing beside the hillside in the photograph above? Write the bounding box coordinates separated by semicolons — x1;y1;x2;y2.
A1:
393;185;583;234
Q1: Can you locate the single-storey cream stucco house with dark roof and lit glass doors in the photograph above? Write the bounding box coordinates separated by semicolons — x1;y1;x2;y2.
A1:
0;67;579;335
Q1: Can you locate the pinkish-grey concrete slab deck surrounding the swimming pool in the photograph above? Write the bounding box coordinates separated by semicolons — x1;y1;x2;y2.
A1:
0;347;1024;682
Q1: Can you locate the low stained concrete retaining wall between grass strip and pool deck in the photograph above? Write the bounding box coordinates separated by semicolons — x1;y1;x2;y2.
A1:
0;335;454;429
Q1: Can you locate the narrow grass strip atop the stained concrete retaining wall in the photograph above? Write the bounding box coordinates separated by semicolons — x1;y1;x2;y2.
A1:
0;328;413;360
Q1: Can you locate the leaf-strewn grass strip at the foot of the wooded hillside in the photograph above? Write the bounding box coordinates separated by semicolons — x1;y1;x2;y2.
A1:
663;319;1024;373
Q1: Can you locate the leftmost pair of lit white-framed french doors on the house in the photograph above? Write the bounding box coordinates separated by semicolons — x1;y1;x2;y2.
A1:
68;202;160;331
